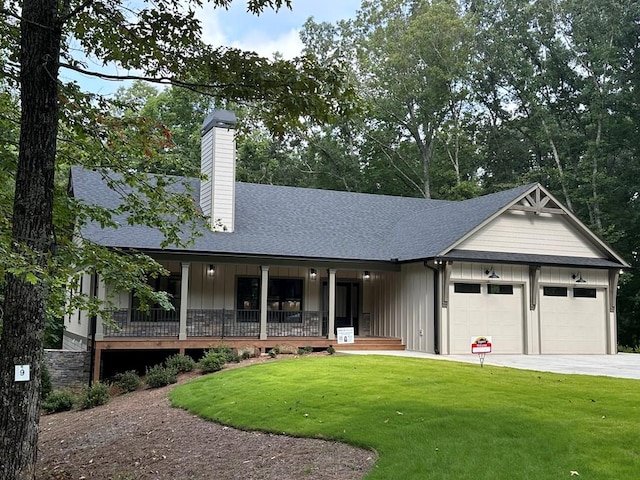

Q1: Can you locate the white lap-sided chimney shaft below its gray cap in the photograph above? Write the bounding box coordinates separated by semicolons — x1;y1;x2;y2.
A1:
200;123;236;232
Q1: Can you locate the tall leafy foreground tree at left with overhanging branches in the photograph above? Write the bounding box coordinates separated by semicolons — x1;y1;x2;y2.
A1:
0;0;356;480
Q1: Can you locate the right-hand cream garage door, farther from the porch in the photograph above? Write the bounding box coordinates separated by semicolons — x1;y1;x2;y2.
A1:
540;286;607;354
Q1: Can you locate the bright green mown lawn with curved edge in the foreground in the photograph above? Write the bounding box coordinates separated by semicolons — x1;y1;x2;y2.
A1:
171;355;640;480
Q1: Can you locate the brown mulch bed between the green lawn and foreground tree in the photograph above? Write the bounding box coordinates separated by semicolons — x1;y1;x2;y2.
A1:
37;357;376;480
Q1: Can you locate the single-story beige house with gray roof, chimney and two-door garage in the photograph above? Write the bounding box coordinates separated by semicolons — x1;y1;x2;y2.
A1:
63;111;628;378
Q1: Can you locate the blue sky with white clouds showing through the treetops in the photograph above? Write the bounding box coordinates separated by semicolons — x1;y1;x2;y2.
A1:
61;0;360;94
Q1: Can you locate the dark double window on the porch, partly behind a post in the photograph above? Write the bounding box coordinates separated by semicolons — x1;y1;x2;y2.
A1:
236;277;303;323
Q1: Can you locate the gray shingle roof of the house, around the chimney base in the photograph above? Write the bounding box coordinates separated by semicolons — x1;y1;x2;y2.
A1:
71;167;620;262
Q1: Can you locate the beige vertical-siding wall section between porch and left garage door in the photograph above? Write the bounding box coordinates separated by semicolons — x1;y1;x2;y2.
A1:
401;262;434;353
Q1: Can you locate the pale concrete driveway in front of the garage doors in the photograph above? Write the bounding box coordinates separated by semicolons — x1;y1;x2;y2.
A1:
338;350;640;380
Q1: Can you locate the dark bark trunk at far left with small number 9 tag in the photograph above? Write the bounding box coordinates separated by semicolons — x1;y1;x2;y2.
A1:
0;0;61;480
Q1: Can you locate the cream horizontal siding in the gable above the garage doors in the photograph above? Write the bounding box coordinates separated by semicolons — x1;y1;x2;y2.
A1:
456;211;603;258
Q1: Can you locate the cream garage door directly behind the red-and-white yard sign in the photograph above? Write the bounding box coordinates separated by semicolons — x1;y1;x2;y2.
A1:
449;283;524;354
